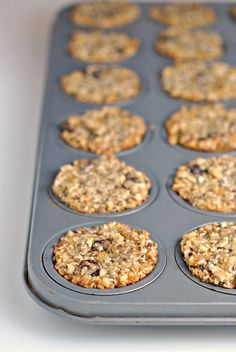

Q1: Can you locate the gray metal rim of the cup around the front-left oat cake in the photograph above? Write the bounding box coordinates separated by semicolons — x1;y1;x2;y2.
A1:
42;222;166;296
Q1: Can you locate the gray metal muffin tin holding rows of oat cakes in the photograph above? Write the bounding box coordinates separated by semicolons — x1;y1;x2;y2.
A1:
24;4;236;325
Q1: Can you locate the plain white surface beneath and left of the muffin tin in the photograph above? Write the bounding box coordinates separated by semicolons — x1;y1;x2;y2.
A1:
0;0;236;352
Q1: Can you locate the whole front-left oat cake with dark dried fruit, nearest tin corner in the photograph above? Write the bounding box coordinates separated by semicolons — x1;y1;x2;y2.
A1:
54;222;158;289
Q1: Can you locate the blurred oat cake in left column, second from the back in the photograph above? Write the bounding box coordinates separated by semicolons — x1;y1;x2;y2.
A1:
67;31;140;63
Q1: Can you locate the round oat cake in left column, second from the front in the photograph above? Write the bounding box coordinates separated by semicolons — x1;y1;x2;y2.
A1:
52;155;151;214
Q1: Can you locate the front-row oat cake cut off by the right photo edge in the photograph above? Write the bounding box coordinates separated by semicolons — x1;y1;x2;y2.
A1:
181;222;236;288
